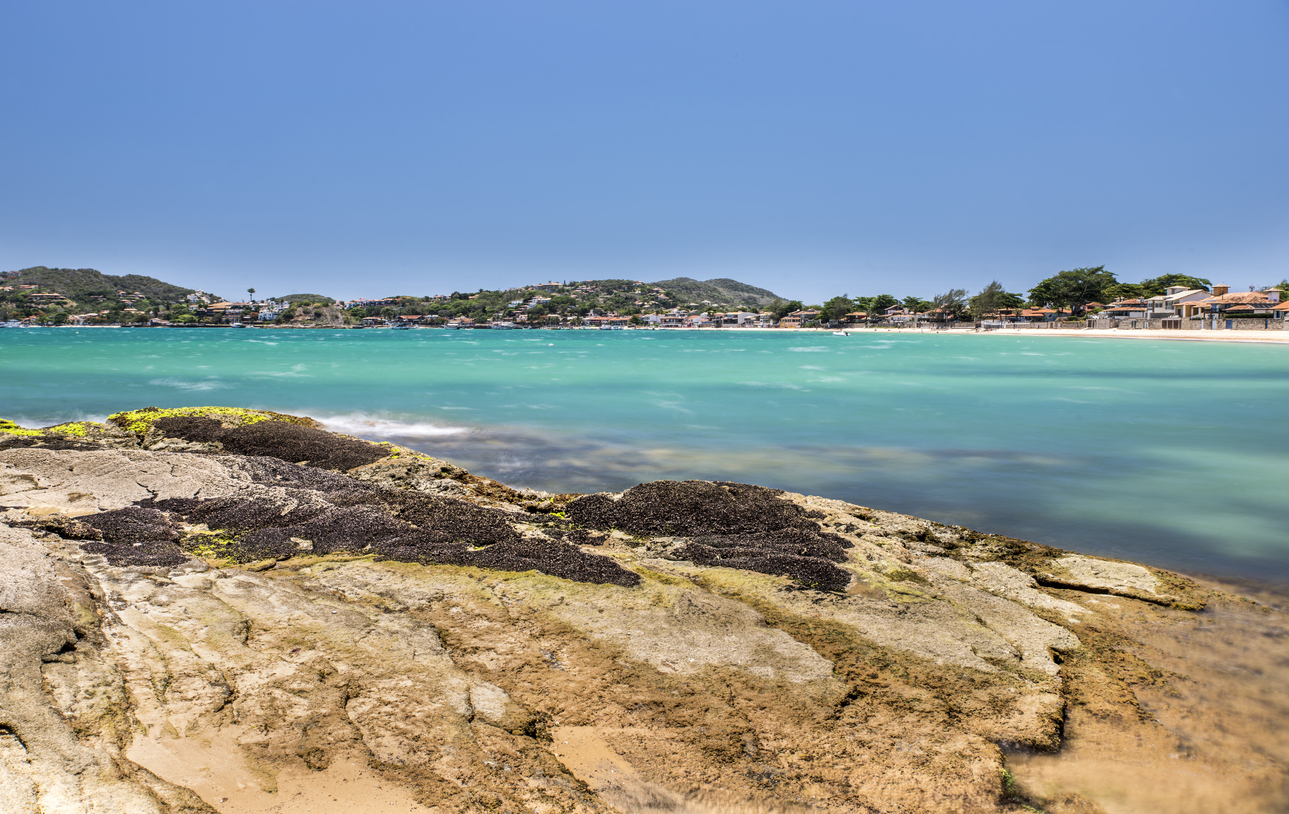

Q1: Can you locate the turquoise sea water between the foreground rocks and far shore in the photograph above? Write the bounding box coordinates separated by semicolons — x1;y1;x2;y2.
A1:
0;329;1289;581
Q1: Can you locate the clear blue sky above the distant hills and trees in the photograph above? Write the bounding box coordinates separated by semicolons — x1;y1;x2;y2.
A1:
0;0;1289;302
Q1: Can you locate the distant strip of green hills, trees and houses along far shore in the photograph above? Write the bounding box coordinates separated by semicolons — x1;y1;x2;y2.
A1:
0;266;1289;329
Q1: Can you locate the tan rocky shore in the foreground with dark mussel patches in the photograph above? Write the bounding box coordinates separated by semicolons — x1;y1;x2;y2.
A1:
0;408;1289;814
